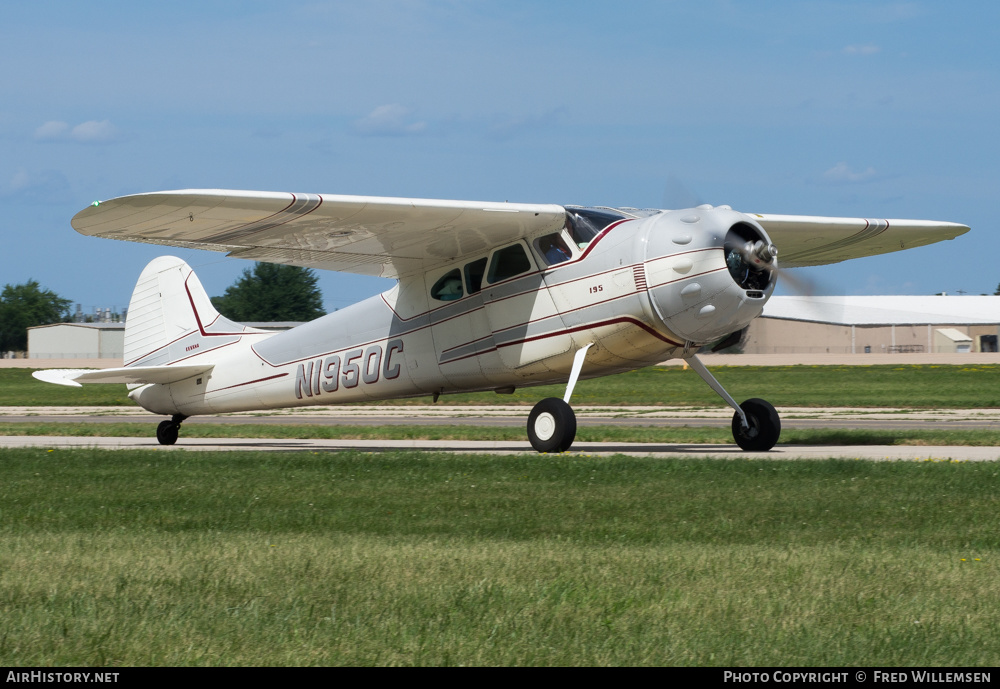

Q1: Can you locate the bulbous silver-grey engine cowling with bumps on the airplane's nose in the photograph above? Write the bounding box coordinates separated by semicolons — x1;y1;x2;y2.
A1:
641;206;778;344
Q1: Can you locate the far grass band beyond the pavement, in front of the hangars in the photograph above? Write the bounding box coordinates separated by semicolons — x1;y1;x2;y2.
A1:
0;365;1000;409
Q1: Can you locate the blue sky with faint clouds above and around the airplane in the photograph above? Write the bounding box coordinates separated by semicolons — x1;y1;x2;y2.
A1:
0;0;1000;311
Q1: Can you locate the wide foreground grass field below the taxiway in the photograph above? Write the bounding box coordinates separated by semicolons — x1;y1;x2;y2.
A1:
0;449;1000;667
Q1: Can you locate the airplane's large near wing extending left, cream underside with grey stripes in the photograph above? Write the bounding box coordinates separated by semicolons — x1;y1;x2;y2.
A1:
72;189;565;278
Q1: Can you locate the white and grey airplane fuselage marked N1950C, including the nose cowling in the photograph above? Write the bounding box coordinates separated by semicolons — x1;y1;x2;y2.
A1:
131;207;774;416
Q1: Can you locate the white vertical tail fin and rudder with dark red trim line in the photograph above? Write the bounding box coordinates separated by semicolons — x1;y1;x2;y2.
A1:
125;256;262;366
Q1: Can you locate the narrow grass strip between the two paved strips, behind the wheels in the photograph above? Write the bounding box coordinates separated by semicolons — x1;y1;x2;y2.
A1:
0;420;1000;447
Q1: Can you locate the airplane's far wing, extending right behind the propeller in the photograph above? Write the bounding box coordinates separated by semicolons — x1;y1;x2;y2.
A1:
747;213;969;268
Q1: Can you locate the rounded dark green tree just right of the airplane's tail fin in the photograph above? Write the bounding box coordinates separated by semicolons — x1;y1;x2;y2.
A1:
212;263;326;323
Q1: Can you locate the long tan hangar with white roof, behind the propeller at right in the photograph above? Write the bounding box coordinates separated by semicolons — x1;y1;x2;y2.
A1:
743;296;1000;354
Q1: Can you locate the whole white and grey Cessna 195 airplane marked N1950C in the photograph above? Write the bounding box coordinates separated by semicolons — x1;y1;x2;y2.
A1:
35;190;969;452
